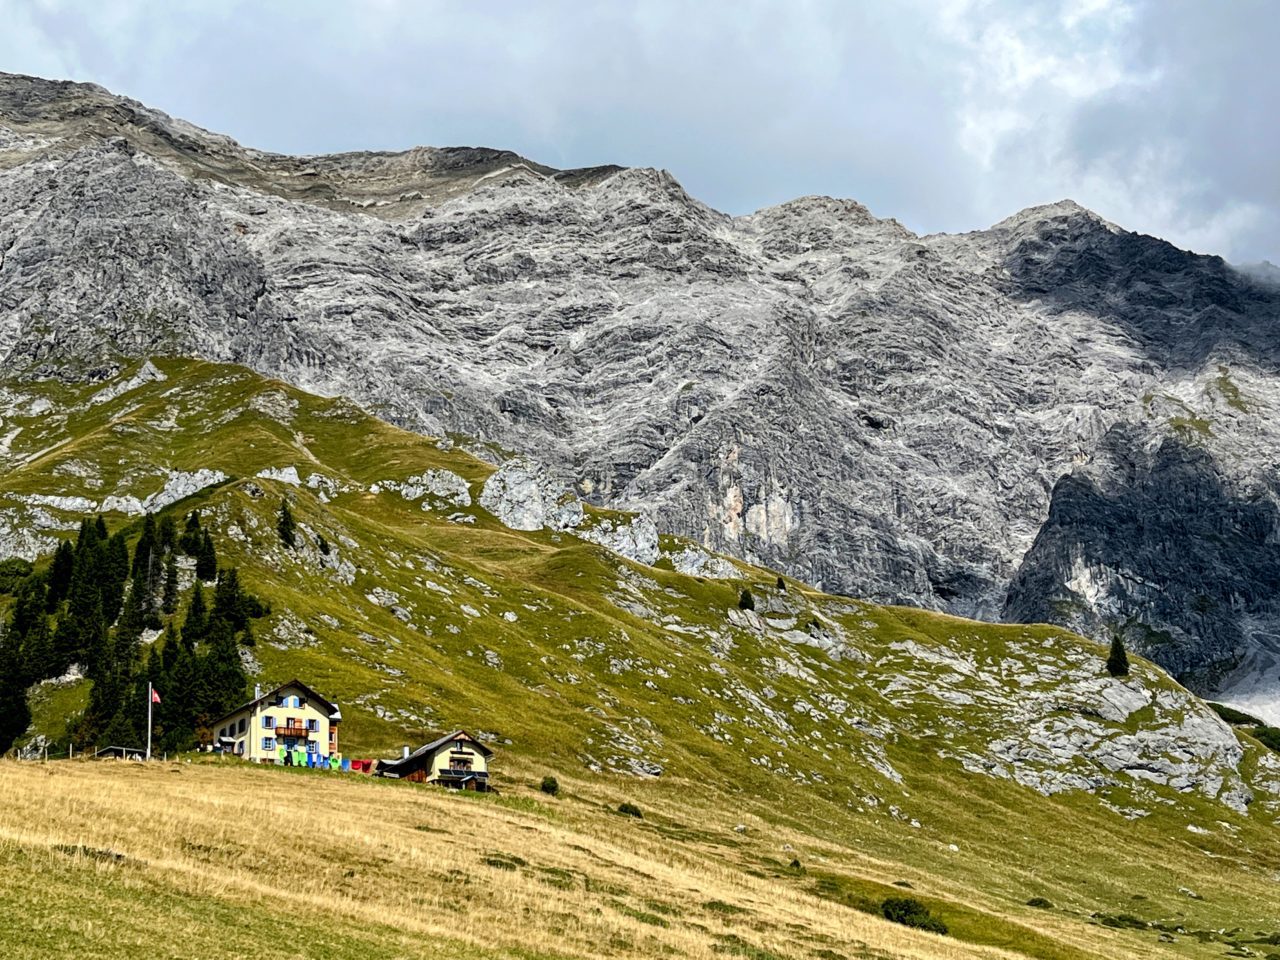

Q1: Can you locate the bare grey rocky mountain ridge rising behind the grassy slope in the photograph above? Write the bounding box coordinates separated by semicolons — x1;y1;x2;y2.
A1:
0;76;1280;722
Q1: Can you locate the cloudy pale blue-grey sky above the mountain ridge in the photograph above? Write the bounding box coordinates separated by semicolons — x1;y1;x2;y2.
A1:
0;0;1280;262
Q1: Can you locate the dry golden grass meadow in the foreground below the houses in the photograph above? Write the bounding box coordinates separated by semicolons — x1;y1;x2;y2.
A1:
0;762;1259;960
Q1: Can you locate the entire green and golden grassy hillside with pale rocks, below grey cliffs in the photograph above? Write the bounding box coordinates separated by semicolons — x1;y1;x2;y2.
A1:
0;361;1280;960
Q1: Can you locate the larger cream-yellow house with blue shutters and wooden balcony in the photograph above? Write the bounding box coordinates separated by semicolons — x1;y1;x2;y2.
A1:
211;680;342;765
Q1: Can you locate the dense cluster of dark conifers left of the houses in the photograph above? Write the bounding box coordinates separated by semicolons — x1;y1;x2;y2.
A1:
0;511;269;753
